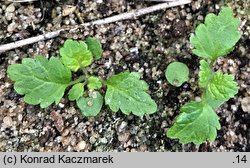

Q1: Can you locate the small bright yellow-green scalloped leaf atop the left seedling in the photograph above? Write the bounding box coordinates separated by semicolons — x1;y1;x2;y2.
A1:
60;39;93;72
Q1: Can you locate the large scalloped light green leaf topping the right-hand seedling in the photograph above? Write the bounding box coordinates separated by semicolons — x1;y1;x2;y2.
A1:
190;7;240;60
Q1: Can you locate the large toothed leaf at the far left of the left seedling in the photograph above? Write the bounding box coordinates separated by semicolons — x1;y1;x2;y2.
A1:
8;56;71;108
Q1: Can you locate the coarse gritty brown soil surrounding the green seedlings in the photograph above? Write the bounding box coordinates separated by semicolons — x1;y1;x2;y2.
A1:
0;0;250;152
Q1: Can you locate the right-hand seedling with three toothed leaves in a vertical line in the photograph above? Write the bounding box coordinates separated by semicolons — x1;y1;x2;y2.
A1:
167;7;240;144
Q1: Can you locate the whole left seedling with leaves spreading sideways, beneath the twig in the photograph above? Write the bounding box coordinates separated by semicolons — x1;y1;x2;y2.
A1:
7;37;157;117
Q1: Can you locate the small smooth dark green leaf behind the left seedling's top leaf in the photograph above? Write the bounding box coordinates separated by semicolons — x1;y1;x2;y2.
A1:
86;37;103;59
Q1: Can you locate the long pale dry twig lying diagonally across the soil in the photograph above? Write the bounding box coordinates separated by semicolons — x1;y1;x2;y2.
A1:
0;0;191;53
